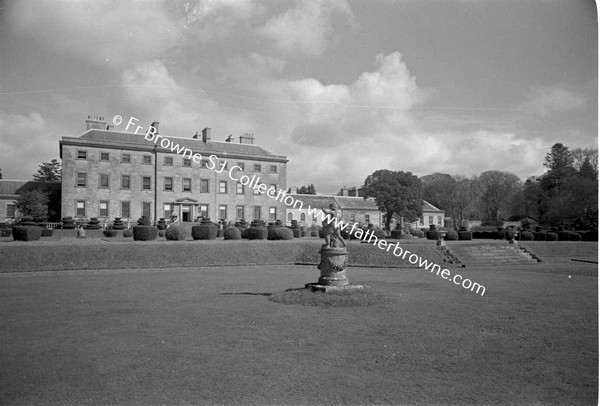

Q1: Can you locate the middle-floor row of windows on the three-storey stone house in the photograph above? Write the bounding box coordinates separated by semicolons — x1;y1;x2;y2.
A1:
75;172;277;195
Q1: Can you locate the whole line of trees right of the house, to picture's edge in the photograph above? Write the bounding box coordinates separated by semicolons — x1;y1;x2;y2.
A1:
364;143;598;229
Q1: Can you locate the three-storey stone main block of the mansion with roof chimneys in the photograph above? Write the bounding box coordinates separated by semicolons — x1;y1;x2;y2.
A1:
60;117;288;222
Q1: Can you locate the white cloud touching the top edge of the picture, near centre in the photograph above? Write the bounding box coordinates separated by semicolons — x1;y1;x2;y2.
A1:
260;0;353;56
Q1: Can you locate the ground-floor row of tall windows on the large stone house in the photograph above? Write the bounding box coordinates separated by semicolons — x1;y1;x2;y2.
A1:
75;200;277;221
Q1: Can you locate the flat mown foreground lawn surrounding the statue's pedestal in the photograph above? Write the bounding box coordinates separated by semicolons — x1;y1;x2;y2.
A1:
0;261;598;405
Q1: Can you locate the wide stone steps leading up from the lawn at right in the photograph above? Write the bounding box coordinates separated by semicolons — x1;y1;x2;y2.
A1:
446;243;538;266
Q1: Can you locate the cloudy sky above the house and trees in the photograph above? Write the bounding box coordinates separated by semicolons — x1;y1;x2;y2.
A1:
0;0;598;193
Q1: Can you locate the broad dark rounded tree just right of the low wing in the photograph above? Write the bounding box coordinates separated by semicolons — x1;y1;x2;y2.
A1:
364;169;423;230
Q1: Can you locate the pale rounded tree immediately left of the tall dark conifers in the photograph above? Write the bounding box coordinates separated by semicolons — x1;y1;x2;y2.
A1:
479;171;522;221
